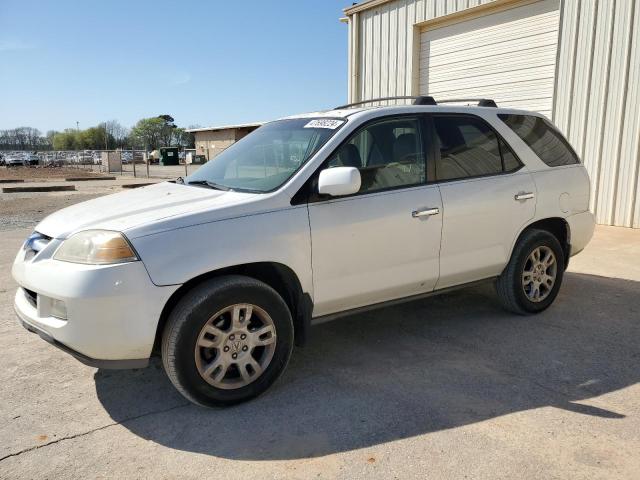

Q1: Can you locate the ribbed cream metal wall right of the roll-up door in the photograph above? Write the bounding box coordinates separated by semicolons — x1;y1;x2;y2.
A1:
553;0;640;228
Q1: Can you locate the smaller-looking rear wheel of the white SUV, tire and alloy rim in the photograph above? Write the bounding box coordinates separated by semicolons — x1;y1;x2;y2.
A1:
496;229;565;315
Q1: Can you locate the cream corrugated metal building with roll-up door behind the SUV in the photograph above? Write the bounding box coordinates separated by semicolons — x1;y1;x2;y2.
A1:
345;0;640;228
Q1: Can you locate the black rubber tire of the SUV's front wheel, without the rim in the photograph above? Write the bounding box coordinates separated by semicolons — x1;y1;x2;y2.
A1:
162;275;293;407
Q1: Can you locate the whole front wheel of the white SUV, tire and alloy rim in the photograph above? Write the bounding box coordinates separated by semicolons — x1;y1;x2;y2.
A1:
162;275;293;406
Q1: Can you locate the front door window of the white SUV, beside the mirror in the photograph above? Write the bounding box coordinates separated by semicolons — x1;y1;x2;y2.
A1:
328;118;426;193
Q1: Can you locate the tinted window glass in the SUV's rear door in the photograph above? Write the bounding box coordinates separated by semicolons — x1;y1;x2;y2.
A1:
433;115;521;180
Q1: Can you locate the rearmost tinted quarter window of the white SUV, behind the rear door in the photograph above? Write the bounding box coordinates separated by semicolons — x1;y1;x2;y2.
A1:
498;114;580;167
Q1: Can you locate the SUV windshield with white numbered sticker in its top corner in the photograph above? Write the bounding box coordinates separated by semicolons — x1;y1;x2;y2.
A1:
184;118;345;192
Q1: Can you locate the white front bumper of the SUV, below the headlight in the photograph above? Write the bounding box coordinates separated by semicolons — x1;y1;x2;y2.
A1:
12;251;178;368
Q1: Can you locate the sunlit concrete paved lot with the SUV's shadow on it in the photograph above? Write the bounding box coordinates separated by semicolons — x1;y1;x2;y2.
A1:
0;193;640;479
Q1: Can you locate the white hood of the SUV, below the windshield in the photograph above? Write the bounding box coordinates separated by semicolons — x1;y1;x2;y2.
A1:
36;182;257;239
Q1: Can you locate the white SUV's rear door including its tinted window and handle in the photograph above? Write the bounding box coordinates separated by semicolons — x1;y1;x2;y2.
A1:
431;114;537;288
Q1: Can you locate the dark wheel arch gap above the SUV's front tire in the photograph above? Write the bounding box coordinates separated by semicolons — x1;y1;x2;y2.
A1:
153;262;313;352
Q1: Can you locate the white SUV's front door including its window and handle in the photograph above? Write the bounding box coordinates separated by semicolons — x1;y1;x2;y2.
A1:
309;116;442;316
